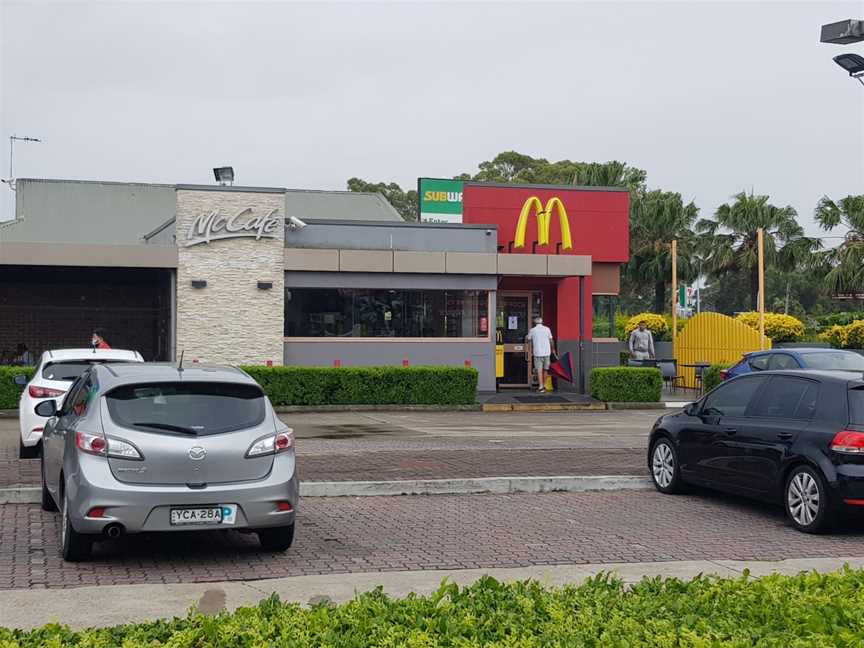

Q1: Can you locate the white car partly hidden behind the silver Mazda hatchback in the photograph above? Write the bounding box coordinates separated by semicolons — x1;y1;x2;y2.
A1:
15;349;144;459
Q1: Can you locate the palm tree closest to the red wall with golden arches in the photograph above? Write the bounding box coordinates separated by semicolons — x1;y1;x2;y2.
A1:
625;190;699;313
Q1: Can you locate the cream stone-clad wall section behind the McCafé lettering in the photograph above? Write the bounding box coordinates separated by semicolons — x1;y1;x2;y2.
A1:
176;189;285;365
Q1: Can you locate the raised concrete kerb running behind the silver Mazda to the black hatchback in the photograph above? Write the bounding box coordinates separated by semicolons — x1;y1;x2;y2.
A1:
0;475;653;504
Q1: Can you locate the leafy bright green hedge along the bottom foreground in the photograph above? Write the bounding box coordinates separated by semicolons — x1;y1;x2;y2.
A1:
0;569;864;648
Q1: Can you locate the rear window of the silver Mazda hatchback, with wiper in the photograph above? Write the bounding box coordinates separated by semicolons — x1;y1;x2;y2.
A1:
105;382;265;436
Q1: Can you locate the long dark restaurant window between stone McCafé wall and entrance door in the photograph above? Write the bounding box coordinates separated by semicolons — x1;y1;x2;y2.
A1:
285;288;489;338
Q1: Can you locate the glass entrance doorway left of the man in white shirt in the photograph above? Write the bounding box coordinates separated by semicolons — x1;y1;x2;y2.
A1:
495;291;543;389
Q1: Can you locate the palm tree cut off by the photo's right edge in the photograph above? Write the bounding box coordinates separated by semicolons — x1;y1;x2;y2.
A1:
815;195;864;293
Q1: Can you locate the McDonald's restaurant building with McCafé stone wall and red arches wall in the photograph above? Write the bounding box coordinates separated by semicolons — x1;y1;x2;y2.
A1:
0;179;629;392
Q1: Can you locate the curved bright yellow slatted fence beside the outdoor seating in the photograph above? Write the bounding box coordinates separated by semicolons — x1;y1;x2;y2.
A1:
675;313;771;387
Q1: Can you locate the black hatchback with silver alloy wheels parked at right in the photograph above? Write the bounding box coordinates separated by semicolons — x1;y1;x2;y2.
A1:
648;371;864;533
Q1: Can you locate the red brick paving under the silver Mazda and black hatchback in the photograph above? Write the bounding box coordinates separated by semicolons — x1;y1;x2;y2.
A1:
0;491;864;588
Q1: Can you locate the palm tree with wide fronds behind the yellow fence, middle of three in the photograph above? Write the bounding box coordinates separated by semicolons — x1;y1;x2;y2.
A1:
696;191;821;308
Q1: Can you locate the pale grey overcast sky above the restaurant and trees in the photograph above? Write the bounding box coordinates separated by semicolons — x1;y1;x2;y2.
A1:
0;0;864;233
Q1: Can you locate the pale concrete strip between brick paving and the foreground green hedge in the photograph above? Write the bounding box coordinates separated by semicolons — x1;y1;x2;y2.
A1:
0;557;864;629
